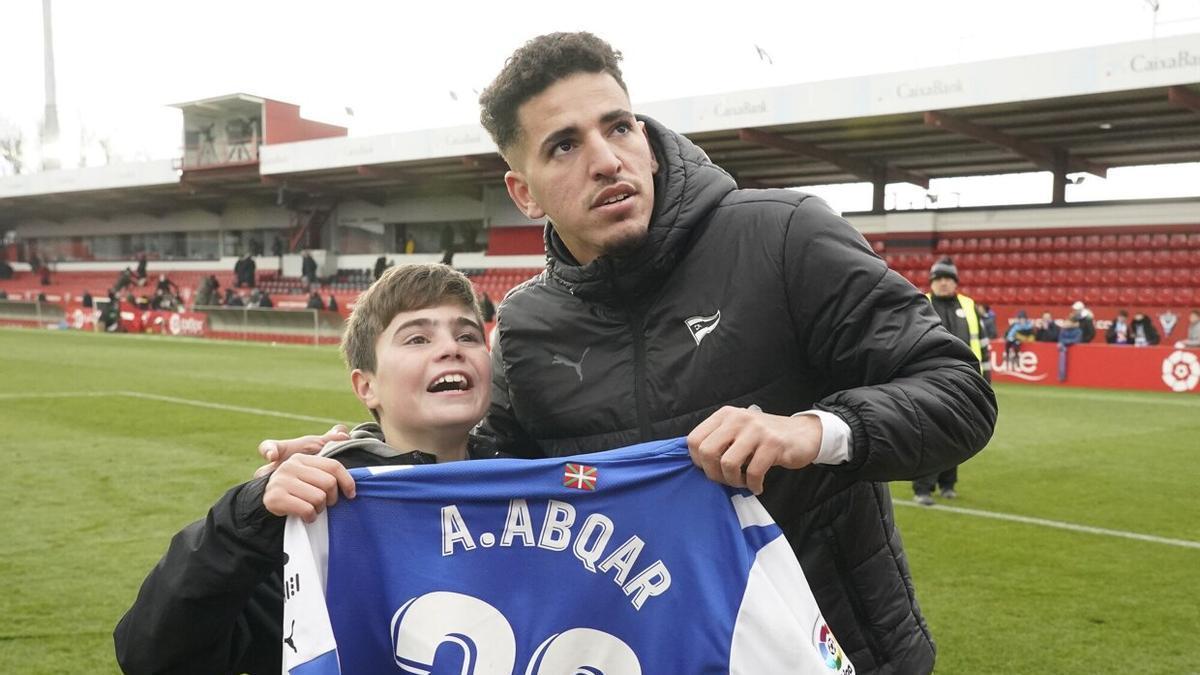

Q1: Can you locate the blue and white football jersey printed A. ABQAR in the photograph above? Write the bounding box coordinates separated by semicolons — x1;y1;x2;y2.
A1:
282;438;854;675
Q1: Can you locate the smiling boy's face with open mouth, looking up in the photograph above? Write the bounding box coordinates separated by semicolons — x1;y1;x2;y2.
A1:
352;304;492;449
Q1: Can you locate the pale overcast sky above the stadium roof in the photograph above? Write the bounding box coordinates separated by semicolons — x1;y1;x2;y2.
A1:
0;0;1200;207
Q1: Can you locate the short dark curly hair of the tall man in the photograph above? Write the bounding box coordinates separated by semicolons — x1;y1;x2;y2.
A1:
479;32;629;156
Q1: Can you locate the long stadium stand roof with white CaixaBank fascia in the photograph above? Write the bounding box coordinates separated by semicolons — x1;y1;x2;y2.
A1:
0;34;1200;225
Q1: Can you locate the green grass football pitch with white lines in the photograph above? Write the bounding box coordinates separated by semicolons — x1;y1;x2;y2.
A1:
0;329;1200;674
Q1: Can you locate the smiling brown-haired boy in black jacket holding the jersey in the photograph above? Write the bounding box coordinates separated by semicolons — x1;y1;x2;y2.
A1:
113;264;494;674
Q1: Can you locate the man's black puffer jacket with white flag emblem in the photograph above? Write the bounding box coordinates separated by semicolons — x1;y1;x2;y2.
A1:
482;119;996;675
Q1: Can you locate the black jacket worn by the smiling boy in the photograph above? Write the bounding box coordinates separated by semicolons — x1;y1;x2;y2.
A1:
113;423;496;675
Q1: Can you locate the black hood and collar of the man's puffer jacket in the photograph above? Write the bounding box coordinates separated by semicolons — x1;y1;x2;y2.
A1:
545;115;737;299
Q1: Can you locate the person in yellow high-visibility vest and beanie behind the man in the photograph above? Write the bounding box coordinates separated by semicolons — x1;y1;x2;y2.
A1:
912;256;991;506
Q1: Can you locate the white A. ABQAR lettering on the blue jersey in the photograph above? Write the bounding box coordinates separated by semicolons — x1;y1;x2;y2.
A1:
442;500;671;610
